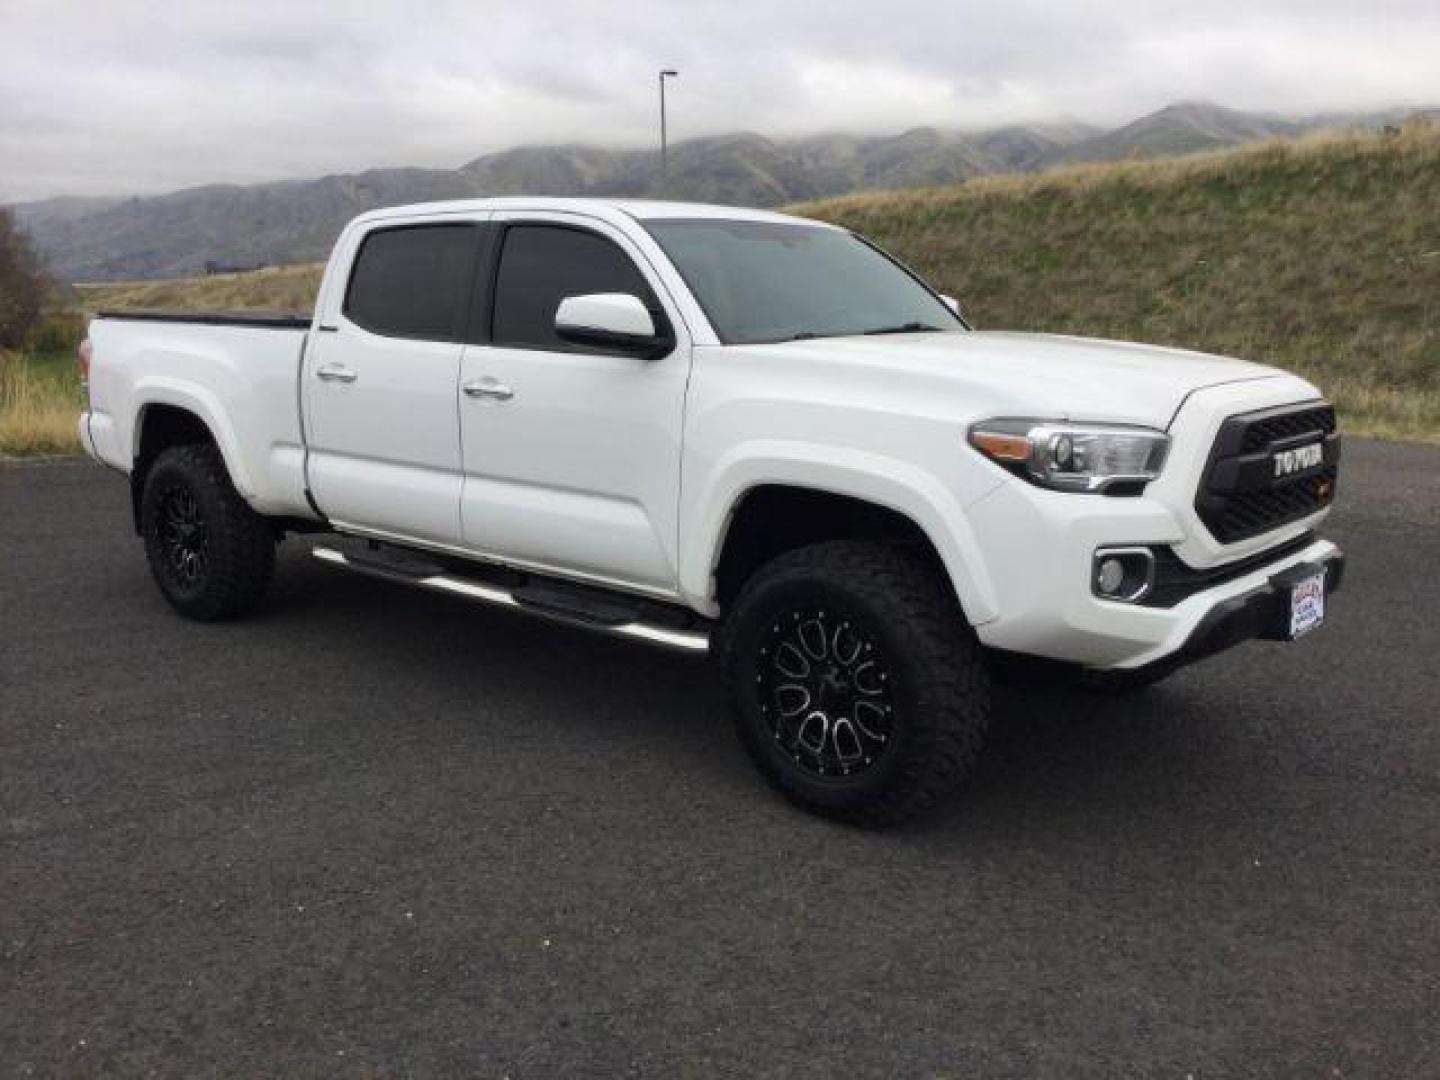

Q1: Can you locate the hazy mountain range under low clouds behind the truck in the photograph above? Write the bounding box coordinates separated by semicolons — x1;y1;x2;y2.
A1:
13;104;1440;281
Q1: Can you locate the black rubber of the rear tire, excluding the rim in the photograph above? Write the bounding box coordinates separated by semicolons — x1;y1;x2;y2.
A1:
144;444;275;622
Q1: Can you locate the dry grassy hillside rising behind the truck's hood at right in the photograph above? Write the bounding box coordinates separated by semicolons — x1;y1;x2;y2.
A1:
789;122;1440;439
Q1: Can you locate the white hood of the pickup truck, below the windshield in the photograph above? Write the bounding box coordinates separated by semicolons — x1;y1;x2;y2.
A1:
750;330;1284;428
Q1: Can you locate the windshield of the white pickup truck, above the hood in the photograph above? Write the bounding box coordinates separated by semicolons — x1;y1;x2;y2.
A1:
644;219;965;346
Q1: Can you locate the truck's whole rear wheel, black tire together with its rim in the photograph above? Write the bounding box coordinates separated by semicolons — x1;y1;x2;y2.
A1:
140;444;276;622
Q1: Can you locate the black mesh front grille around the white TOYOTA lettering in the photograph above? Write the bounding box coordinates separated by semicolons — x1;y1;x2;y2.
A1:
1195;402;1341;544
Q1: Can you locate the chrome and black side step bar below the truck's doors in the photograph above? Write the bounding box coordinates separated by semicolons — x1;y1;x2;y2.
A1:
311;546;710;652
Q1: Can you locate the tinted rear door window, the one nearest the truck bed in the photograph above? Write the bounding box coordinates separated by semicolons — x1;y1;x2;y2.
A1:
346;225;480;341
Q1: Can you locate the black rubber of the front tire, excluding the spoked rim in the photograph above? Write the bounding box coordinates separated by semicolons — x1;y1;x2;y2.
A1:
714;540;989;827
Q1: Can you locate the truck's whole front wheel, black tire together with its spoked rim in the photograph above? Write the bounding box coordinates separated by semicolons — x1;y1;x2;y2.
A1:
716;540;989;827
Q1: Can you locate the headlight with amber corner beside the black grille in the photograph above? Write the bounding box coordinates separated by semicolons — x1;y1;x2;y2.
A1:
971;420;1169;495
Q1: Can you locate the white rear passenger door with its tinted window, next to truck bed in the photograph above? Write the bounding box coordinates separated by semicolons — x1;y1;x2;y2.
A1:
302;217;485;546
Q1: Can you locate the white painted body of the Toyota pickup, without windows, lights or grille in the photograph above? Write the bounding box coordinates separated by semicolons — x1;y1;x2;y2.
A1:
81;199;1333;667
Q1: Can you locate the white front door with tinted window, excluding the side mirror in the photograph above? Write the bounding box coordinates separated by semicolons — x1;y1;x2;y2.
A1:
459;212;690;595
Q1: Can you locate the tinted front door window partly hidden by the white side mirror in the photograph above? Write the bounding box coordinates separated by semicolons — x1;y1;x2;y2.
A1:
492;225;658;351
